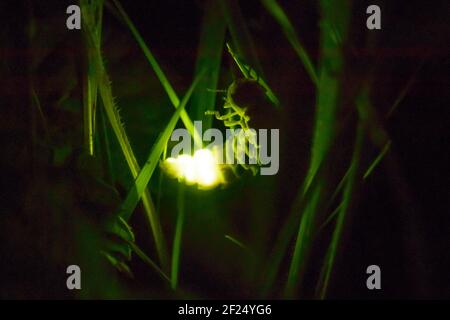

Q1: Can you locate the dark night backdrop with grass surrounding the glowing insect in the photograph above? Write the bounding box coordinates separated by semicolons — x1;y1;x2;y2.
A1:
0;0;450;299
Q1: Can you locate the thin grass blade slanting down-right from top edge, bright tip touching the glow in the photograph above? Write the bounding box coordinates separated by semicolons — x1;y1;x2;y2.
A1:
111;0;202;146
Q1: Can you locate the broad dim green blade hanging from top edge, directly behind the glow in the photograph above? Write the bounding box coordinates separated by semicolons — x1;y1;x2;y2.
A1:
190;0;226;130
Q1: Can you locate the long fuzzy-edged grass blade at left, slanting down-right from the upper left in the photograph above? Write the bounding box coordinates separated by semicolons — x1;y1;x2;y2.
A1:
81;3;168;268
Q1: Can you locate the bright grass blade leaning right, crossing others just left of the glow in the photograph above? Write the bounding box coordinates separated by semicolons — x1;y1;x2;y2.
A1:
119;76;201;220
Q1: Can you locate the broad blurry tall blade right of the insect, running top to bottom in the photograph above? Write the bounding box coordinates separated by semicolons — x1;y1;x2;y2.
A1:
285;0;350;297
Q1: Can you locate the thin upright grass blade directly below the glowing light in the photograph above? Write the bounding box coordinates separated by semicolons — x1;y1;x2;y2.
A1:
171;184;185;290
